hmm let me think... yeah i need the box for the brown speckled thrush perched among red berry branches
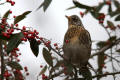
[63,15,92,80]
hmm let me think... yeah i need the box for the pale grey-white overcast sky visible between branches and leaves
[0,0,119,80]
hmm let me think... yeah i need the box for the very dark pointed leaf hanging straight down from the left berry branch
[29,39,39,57]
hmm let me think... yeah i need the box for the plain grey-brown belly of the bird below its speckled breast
[64,42,89,65]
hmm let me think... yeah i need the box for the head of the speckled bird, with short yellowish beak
[66,15,83,27]
